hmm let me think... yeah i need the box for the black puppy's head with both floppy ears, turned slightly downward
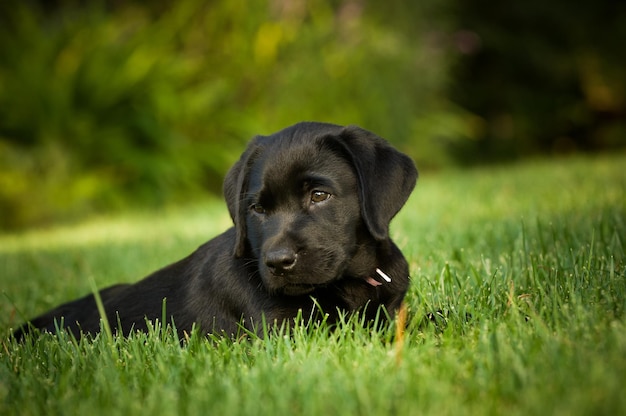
[224,123,417,295]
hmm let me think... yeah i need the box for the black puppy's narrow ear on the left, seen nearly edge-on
[223,136,264,257]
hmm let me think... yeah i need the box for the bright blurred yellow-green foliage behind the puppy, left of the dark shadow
[0,0,454,229]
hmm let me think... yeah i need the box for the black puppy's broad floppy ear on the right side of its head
[339,126,417,241]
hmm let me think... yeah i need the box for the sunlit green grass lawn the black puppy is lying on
[0,155,626,415]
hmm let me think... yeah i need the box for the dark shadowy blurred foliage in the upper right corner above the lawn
[448,0,626,163]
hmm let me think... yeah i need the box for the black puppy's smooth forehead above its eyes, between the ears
[250,140,356,191]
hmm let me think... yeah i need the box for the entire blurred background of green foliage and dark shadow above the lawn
[0,0,626,231]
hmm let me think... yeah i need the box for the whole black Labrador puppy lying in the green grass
[14,123,417,339]
